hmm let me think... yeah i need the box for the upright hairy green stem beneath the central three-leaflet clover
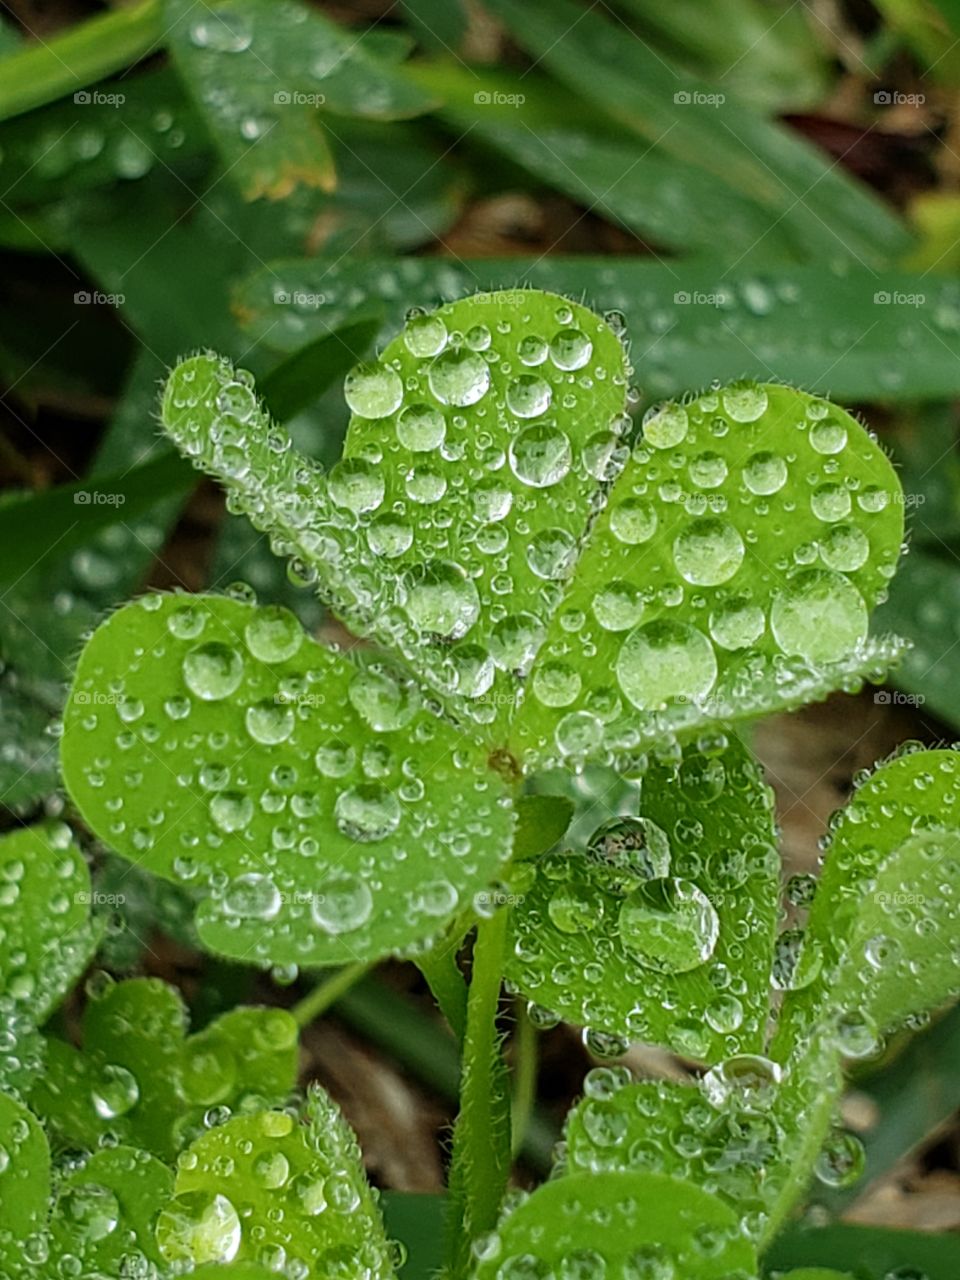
[449,908,512,1276]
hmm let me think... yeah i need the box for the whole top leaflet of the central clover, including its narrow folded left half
[164,291,627,732]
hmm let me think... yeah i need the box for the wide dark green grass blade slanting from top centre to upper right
[488,0,909,265]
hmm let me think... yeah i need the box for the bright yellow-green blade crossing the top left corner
[0,0,164,120]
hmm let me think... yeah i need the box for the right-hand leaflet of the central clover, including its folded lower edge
[511,381,904,767]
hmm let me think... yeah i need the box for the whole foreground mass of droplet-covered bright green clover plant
[0,290,960,1280]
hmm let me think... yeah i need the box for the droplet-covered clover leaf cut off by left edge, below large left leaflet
[0,822,99,1025]
